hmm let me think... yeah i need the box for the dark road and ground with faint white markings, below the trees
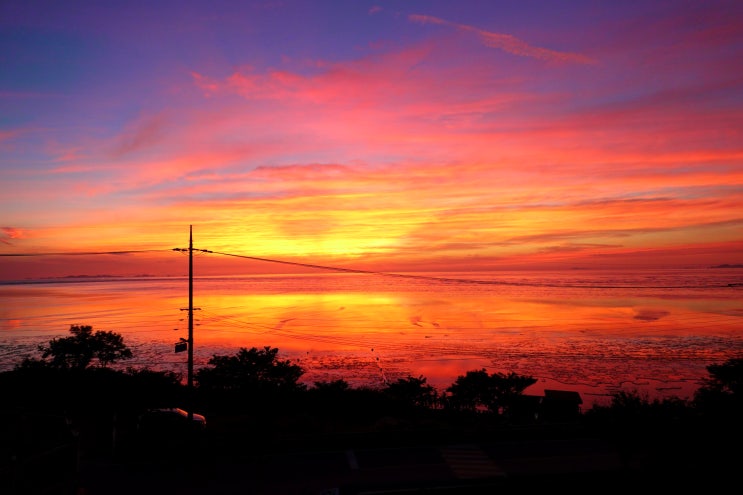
[8,414,742,495]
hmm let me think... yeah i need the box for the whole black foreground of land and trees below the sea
[5,348,743,495]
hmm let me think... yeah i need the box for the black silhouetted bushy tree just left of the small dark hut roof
[446,368,537,415]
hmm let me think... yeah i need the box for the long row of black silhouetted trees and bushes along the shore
[5,325,743,423]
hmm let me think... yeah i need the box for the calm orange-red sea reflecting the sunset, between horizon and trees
[0,268,743,407]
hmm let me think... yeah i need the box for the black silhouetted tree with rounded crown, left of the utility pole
[28,325,132,369]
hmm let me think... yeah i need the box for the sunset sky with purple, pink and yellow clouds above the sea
[0,0,743,280]
